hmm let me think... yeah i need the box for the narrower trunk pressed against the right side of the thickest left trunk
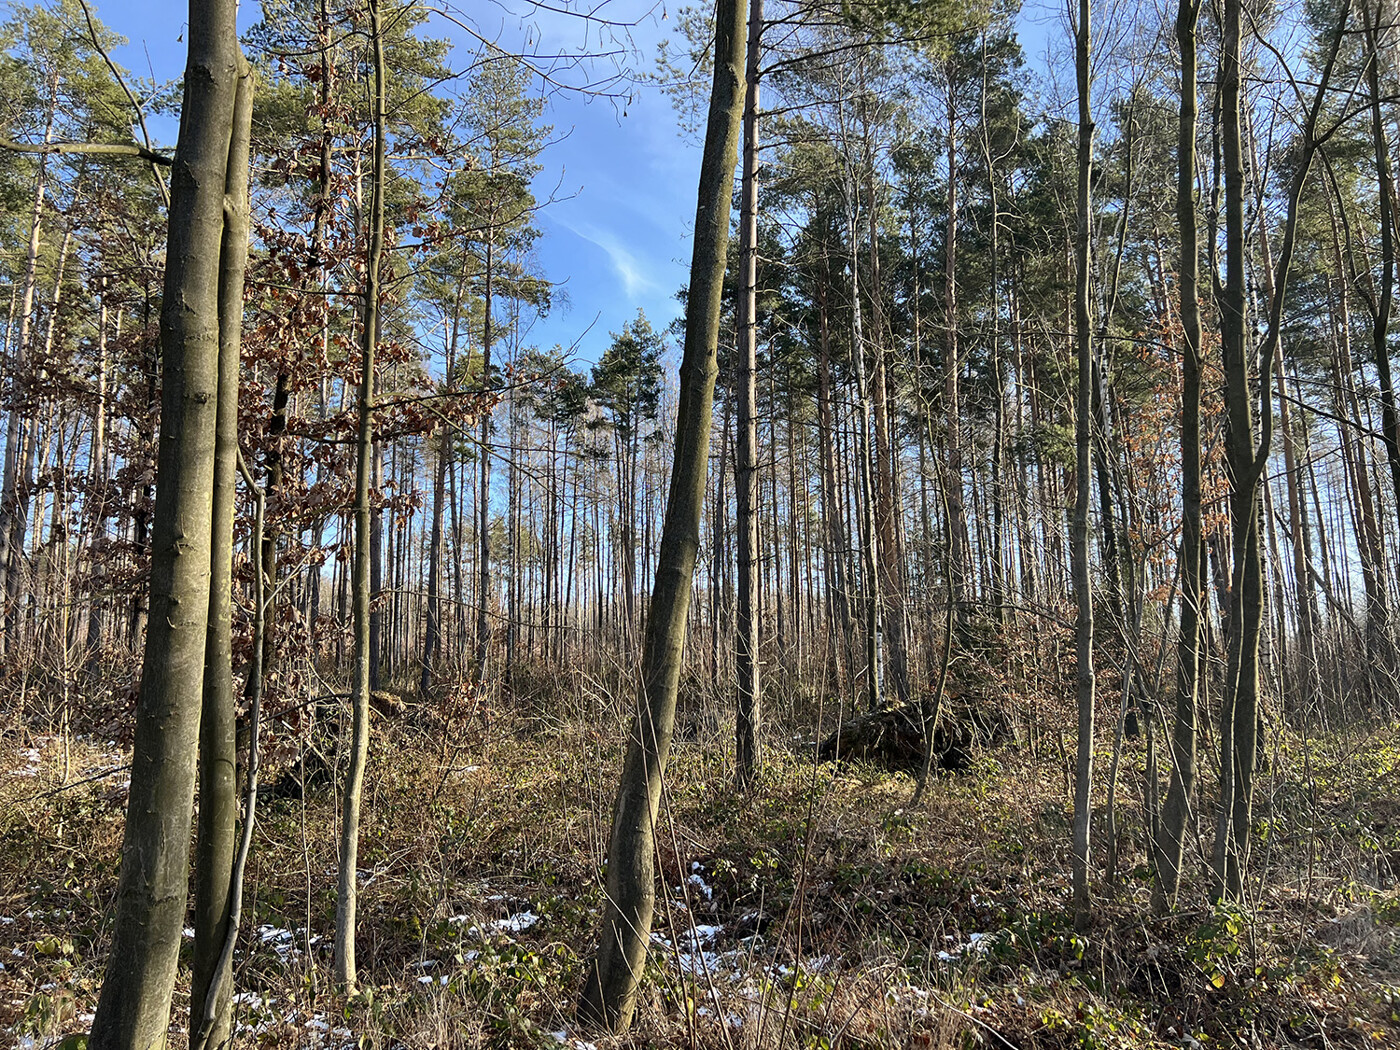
[189,63,254,1050]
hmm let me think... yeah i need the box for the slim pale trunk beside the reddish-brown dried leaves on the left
[335,0,385,991]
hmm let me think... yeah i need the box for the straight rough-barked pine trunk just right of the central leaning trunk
[734,0,763,791]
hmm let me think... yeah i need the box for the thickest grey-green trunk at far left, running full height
[90,0,242,1050]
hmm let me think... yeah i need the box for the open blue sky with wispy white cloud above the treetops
[99,0,1061,361]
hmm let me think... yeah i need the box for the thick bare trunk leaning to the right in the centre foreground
[578,0,745,1032]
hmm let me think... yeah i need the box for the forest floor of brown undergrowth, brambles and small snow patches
[0,666,1400,1050]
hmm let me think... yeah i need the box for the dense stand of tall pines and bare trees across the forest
[0,0,1400,1046]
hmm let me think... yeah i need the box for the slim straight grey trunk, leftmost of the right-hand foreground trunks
[1070,0,1093,930]
